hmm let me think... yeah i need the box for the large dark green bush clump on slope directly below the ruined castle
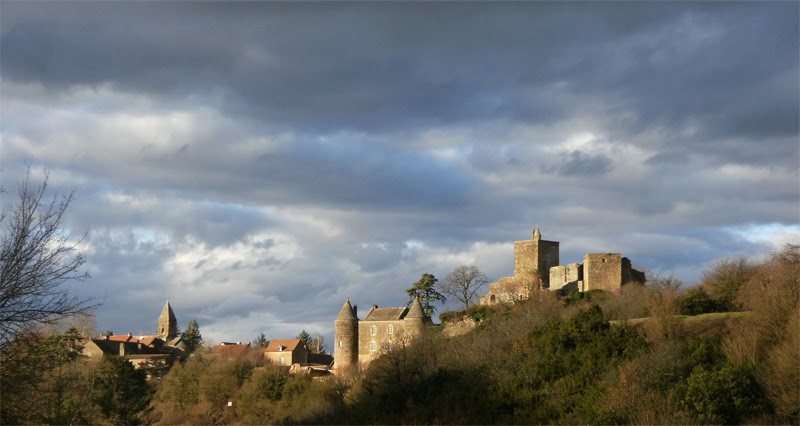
[506,306,646,423]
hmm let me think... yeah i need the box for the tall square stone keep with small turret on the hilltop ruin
[514,226,559,288]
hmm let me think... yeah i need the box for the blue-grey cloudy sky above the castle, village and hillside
[0,0,800,348]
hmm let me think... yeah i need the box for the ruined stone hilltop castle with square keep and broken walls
[480,227,645,305]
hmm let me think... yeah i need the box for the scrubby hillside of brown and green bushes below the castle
[2,246,800,424]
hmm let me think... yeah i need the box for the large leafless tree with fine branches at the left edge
[0,169,94,349]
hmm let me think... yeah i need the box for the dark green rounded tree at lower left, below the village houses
[91,357,153,425]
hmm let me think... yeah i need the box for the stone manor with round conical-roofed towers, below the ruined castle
[334,298,432,375]
